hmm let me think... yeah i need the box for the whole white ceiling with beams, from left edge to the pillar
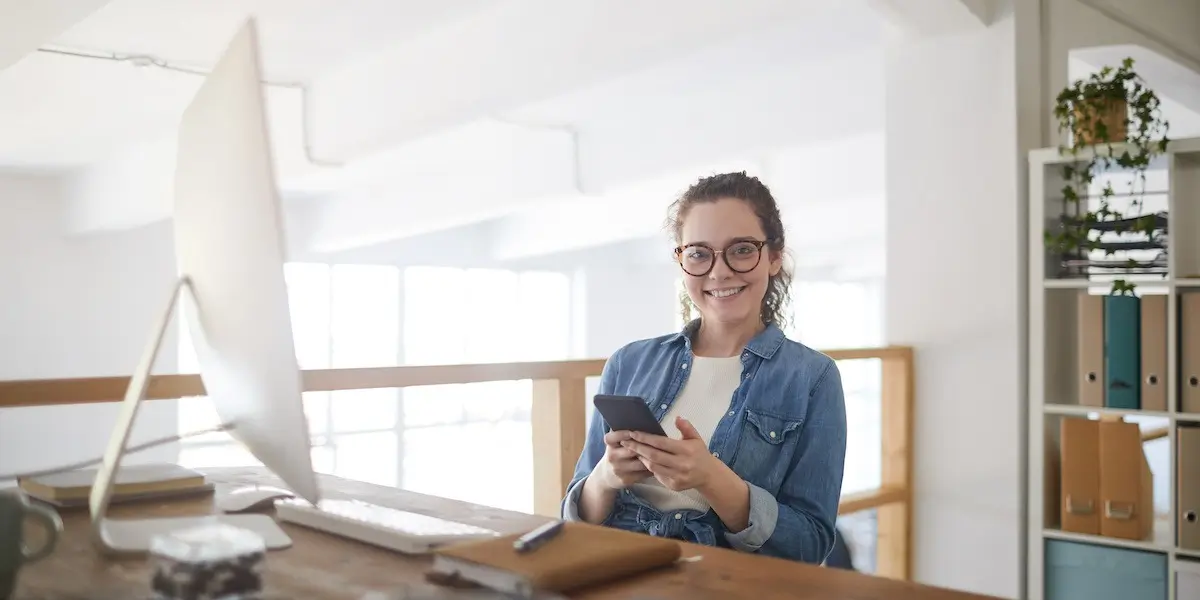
[0,0,884,272]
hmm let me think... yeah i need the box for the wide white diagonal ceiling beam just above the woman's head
[302,46,883,253]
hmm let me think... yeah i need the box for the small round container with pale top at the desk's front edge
[150,522,266,600]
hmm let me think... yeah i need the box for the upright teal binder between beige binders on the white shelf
[1104,295,1141,410]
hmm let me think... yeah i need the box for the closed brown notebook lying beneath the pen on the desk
[430,522,682,599]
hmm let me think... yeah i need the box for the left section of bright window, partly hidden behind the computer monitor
[179,263,401,485]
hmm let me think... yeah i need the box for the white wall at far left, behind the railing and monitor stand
[0,175,178,473]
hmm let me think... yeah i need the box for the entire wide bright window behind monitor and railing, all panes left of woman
[179,263,571,511]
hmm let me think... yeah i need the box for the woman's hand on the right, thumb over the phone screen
[622,416,725,492]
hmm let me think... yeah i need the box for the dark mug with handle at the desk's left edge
[0,488,62,599]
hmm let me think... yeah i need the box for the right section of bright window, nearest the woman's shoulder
[403,266,571,512]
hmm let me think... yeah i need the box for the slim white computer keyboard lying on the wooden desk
[275,498,500,554]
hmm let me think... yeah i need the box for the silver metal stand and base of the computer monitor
[88,277,292,556]
